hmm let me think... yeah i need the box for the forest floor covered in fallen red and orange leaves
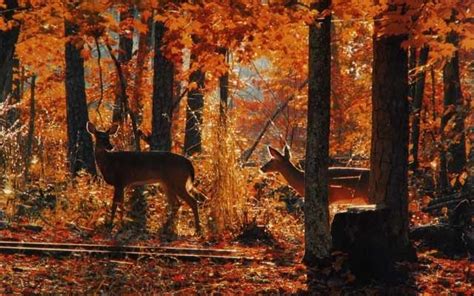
[0,213,474,295]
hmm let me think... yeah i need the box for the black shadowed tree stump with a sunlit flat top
[331,205,416,281]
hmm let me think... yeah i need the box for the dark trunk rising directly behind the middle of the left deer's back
[150,22,175,151]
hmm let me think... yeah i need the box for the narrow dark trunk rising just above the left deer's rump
[184,55,205,155]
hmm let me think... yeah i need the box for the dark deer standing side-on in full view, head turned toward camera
[86,122,207,234]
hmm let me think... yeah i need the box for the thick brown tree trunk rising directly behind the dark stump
[369,19,411,258]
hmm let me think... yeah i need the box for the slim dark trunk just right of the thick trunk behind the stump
[411,46,429,172]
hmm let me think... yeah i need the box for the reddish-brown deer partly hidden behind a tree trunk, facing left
[260,146,370,204]
